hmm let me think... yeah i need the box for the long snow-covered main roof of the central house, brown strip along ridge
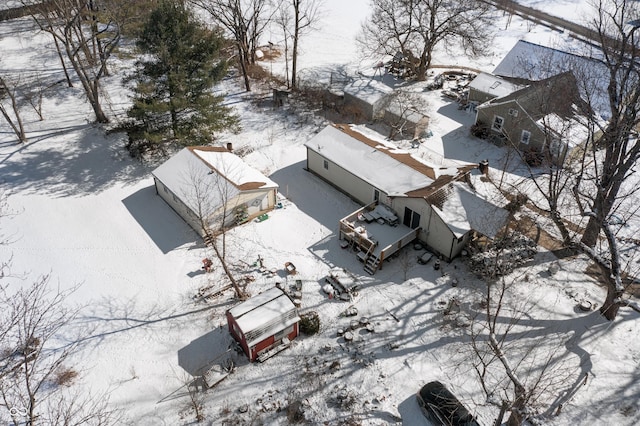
[305,125,470,196]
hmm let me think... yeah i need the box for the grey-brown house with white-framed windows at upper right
[476,72,591,164]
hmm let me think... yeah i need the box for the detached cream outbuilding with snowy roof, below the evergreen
[152,146,278,237]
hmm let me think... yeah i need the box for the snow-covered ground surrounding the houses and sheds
[0,0,640,425]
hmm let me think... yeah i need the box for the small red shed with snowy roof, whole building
[227,287,300,361]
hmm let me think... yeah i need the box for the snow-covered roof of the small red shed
[229,287,300,347]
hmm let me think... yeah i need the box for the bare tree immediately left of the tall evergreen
[23,0,121,123]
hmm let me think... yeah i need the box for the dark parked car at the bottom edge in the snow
[416,381,480,426]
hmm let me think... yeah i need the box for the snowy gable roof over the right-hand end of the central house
[433,182,509,238]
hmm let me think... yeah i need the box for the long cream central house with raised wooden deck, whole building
[305,125,508,273]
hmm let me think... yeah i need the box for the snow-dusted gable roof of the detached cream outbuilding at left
[152,146,278,215]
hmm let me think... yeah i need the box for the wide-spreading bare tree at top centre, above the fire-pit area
[358,0,492,80]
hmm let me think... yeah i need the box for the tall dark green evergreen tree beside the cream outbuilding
[128,0,238,157]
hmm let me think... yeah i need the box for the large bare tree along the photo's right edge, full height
[524,0,640,320]
